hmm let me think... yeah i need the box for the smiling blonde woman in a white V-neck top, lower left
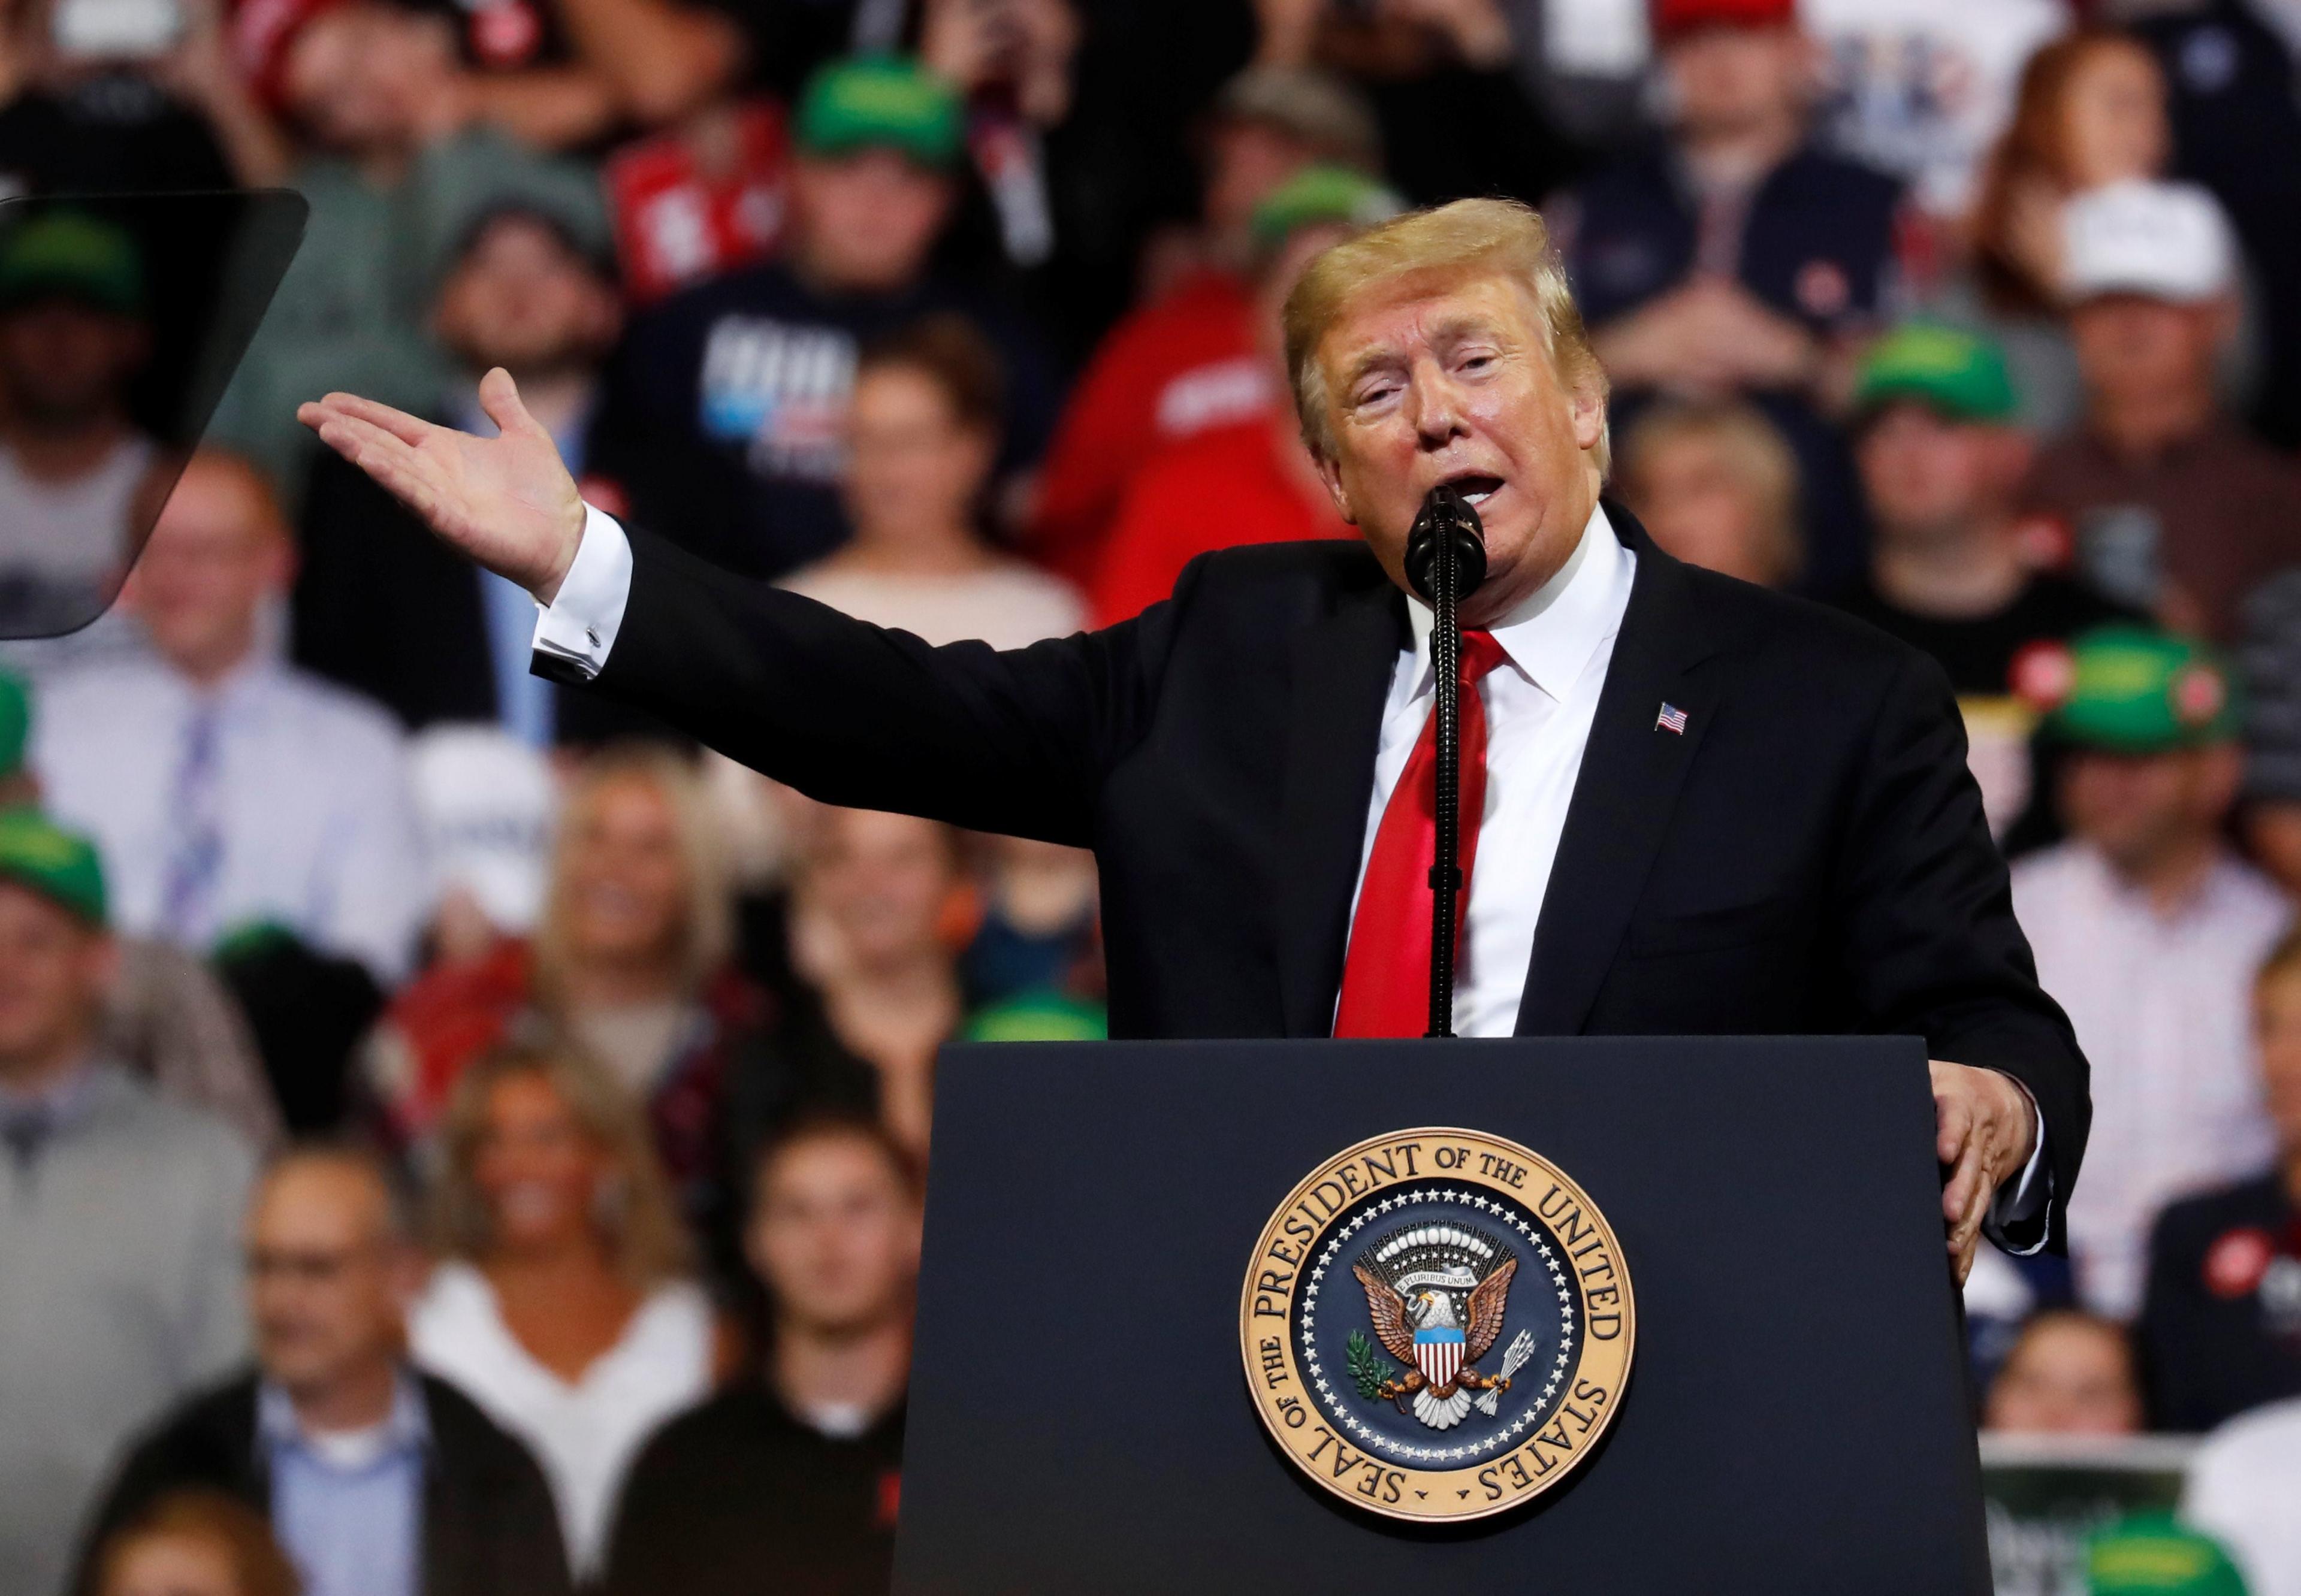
[410,1048,715,1577]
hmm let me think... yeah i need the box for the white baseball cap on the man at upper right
[2062,179,2236,304]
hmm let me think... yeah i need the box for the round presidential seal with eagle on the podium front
[1238,1129,1636,1520]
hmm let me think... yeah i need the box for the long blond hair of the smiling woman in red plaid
[534,743,734,1007]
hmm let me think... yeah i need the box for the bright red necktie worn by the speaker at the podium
[1334,633,1503,1037]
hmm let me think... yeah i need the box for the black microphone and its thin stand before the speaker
[1406,485,1487,1037]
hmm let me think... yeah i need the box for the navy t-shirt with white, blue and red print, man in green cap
[598,262,1061,577]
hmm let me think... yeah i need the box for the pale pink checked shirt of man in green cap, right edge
[2013,842,2292,1318]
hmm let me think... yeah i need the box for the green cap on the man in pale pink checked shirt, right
[2048,621,2239,754]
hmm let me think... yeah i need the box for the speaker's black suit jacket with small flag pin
[539,506,2089,1241]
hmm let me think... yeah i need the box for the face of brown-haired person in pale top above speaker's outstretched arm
[844,365,992,548]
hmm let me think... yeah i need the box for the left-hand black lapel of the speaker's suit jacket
[1277,572,1406,1037]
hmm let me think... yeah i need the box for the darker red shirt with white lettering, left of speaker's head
[1031,271,1279,582]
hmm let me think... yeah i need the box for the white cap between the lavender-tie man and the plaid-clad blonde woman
[407,724,557,933]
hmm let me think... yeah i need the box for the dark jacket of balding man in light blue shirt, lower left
[74,1373,568,1596]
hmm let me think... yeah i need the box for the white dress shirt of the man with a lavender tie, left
[32,651,430,984]
